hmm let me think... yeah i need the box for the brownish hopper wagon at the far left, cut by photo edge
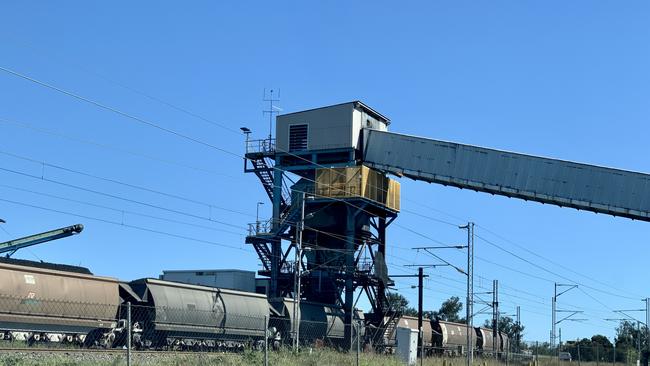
[0,260,121,347]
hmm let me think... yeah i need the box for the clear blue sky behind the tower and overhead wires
[0,1,650,341]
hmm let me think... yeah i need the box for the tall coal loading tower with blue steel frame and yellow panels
[243,101,400,346]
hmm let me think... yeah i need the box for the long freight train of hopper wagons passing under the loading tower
[0,258,508,356]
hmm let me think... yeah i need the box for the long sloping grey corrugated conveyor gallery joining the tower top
[364,129,650,221]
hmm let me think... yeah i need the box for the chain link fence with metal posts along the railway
[6,295,640,366]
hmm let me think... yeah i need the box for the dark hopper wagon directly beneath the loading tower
[270,298,365,346]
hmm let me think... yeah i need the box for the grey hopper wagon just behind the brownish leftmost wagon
[123,278,270,350]
